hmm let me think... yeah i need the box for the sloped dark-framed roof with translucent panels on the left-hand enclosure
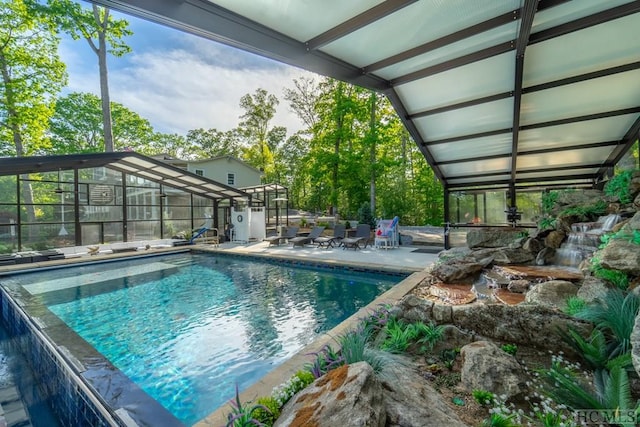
[0,152,251,199]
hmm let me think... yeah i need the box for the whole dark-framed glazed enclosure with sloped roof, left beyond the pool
[0,152,269,253]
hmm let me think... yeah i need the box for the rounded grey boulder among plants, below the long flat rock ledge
[460,341,527,399]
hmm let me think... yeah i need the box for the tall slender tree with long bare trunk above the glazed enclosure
[30,0,133,151]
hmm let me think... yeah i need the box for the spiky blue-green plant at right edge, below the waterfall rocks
[576,289,640,357]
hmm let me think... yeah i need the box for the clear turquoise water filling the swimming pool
[32,254,402,425]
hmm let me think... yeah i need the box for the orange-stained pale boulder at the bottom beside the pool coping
[274,362,387,427]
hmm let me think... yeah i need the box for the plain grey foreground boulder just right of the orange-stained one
[380,360,466,427]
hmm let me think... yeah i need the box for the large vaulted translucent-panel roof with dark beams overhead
[90,0,640,190]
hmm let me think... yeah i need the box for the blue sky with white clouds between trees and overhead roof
[60,7,317,135]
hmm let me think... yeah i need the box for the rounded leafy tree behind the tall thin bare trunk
[49,92,154,154]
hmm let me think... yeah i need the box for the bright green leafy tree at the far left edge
[0,0,67,227]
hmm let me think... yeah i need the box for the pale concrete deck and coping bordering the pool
[0,242,438,427]
